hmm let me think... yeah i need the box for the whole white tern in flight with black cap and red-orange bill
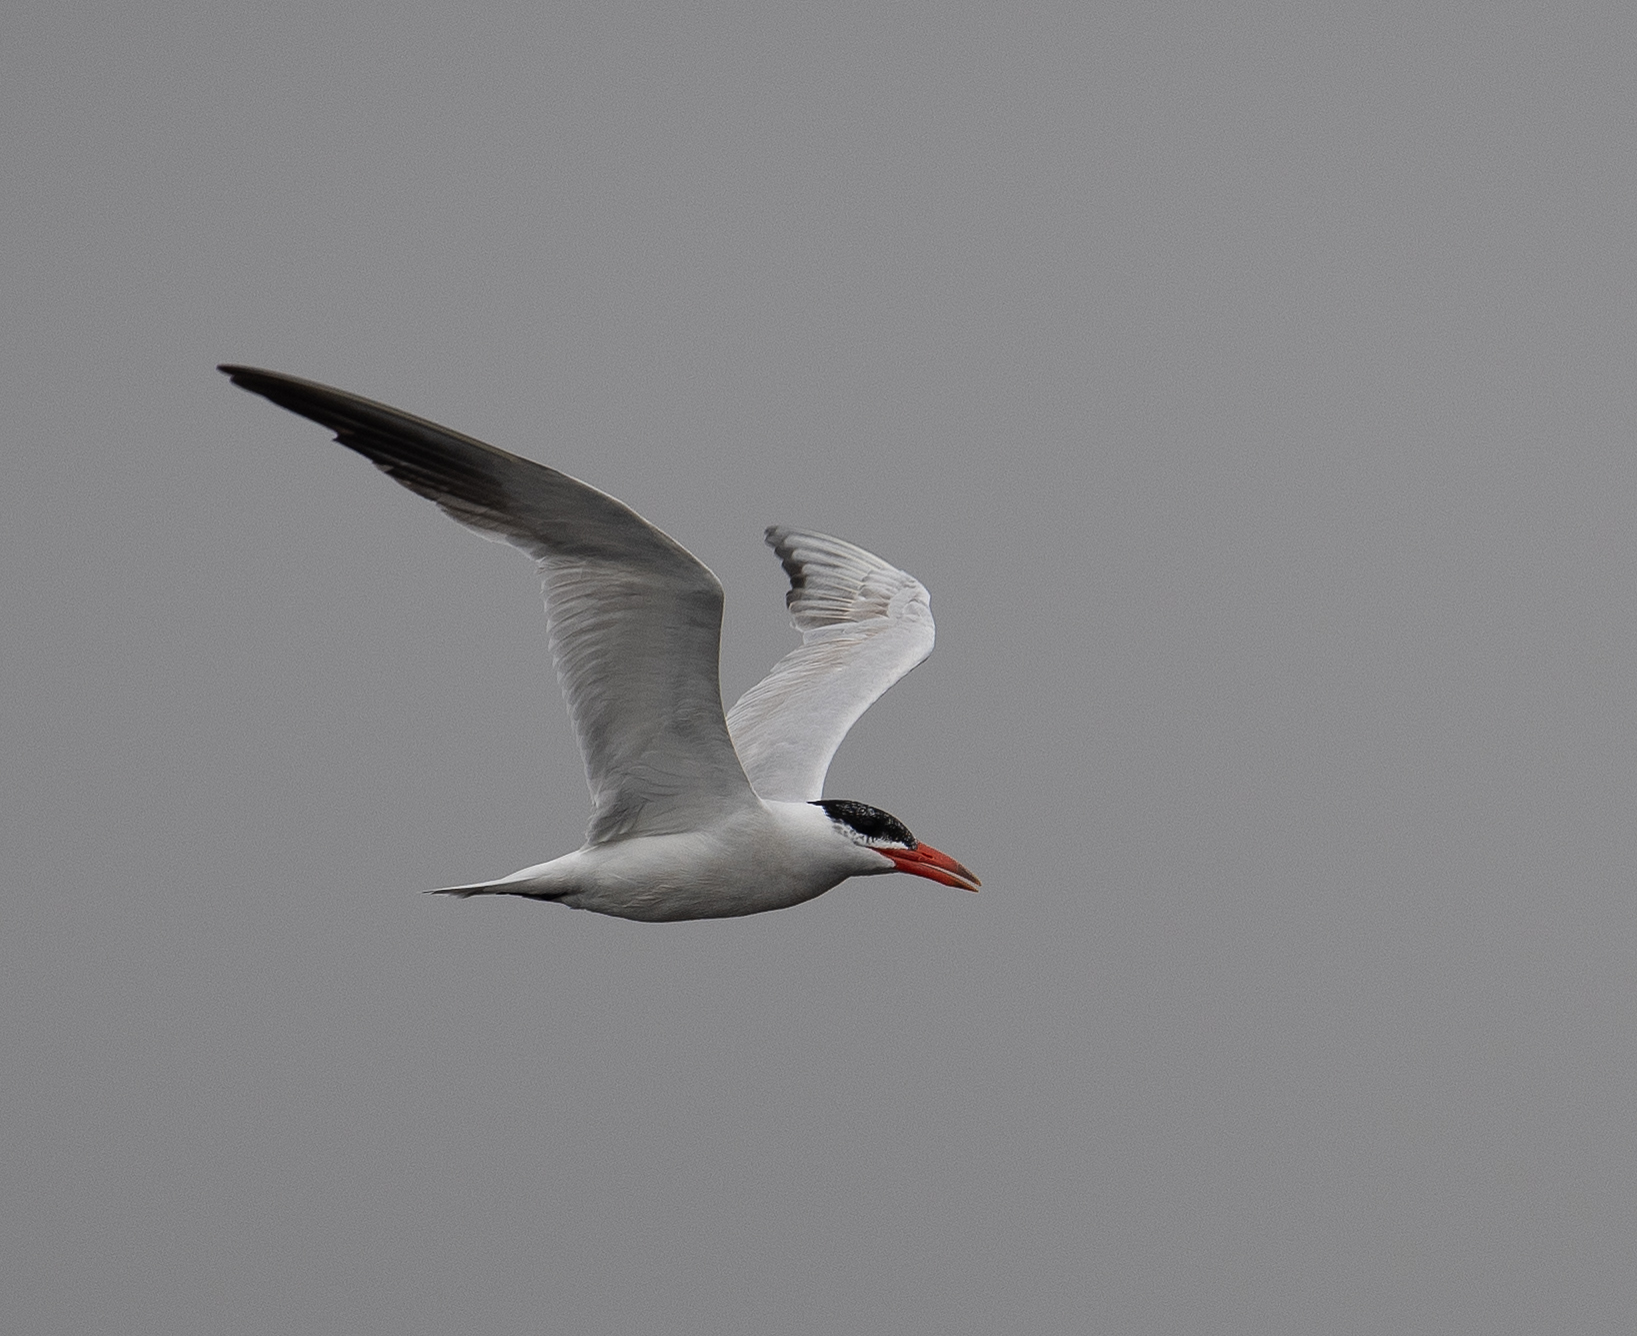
[218,363,979,923]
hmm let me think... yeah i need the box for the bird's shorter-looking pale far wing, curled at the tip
[727,526,933,802]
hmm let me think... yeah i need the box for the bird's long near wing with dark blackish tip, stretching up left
[221,367,755,843]
